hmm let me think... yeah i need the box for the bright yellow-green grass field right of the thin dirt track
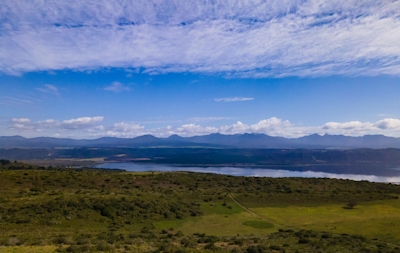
[251,199,400,244]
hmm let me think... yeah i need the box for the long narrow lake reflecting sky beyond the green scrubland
[95,163,400,184]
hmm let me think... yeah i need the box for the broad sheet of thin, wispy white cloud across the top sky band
[0,0,400,77]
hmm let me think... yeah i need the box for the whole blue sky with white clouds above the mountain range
[0,0,400,139]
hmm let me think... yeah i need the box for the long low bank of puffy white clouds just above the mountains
[9,116,400,138]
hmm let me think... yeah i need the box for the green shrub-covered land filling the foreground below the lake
[0,160,400,253]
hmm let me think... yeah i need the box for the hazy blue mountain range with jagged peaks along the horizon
[0,134,400,149]
